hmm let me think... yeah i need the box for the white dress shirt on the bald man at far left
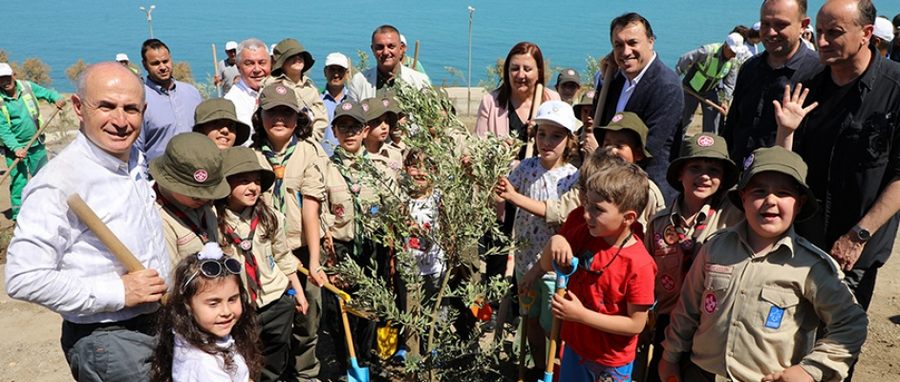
[6,132,169,324]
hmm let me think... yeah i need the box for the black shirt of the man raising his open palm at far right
[794,50,900,269]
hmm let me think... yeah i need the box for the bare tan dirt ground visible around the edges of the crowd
[0,97,900,382]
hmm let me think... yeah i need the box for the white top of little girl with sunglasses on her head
[172,334,250,382]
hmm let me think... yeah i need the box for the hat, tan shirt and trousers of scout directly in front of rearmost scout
[257,83,325,379]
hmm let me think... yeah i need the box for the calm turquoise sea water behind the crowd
[0,0,836,91]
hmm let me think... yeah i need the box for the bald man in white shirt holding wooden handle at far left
[6,62,170,382]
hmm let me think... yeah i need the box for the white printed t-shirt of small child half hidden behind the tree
[406,191,444,276]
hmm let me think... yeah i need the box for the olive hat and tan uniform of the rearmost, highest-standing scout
[262,38,328,143]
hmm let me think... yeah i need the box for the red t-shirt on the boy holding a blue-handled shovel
[559,211,656,367]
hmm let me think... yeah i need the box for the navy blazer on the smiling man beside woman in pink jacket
[595,55,684,205]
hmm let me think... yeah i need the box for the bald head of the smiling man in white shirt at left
[72,62,146,162]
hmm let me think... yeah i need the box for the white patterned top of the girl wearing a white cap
[509,157,578,277]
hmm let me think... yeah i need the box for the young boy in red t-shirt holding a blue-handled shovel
[526,164,656,382]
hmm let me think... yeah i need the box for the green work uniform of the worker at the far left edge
[0,81,62,220]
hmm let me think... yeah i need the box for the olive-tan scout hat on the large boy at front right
[728,146,818,221]
